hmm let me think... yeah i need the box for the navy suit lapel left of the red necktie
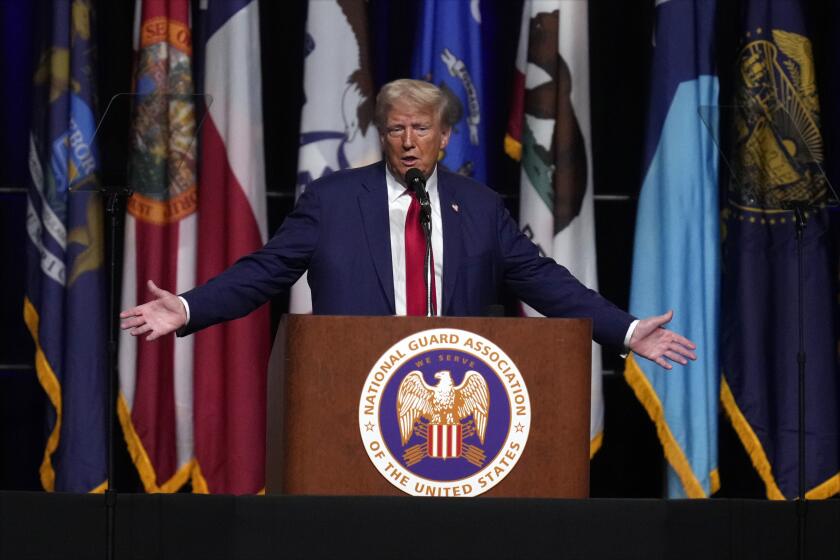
[358,165,396,315]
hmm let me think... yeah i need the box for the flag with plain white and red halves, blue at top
[193,0,270,494]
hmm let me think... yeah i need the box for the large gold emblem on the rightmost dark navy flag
[730,29,830,210]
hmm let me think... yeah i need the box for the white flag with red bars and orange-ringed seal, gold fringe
[119,0,197,492]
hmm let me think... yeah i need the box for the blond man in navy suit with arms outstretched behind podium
[120,80,695,369]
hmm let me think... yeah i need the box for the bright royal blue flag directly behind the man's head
[411,0,488,183]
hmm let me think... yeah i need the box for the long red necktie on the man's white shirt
[405,191,437,316]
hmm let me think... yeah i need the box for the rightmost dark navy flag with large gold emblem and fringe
[721,0,840,499]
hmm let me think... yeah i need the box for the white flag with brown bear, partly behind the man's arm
[505,0,604,455]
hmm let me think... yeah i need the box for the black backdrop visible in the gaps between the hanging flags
[0,0,840,497]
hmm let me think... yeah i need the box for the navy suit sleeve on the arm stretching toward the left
[178,184,321,336]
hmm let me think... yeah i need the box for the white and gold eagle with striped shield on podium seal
[397,370,490,466]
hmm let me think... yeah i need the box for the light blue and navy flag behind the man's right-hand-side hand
[625,0,720,498]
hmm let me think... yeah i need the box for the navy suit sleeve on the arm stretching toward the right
[496,199,635,346]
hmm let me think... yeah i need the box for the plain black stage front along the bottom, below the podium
[0,492,840,560]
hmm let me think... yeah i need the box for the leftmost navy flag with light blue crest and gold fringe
[24,0,108,492]
